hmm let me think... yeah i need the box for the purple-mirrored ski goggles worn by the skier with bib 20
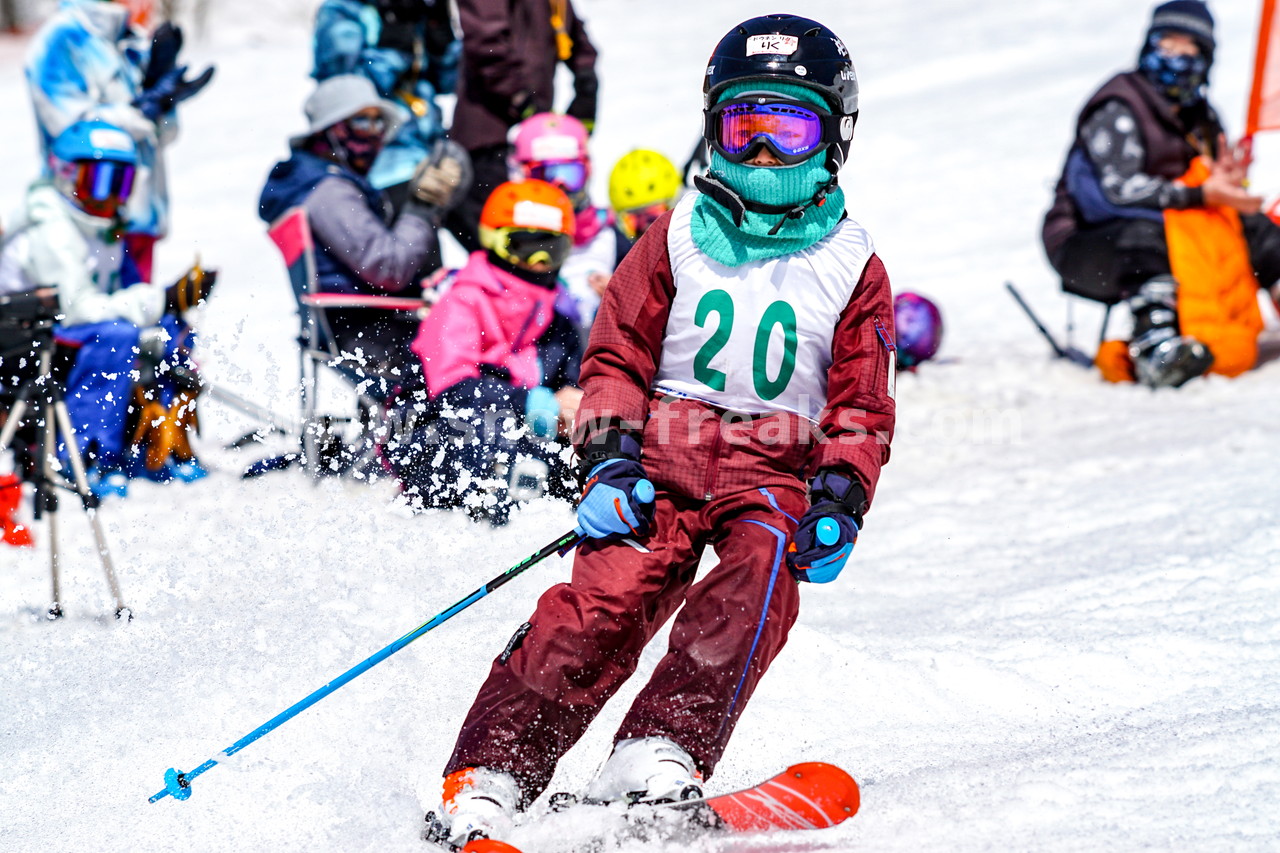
[704,97,852,165]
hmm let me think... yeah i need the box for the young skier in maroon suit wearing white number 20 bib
[426,15,895,844]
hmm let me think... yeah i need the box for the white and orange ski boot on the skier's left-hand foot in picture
[422,767,520,848]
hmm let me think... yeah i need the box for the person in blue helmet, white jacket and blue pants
[0,116,216,496]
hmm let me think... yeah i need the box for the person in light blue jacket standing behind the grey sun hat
[311,0,462,211]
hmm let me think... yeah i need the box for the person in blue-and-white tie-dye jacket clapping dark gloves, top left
[26,0,214,279]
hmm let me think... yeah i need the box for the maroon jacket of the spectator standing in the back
[449,0,598,151]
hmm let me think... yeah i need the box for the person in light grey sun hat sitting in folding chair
[259,74,470,391]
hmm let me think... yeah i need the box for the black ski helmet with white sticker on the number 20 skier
[703,14,858,172]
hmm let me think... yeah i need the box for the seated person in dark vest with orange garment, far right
[1043,0,1280,387]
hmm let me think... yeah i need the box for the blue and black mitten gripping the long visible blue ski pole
[577,429,654,539]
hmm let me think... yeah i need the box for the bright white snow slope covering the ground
[0,0,1280,852]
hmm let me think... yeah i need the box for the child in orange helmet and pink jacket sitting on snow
[387,181,582,525]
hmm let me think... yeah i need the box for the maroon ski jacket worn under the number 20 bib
[575,213,895,501]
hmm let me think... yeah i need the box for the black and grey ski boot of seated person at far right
[1129,275,1213,388]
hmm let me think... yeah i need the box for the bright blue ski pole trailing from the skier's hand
[147,530,582,803]
